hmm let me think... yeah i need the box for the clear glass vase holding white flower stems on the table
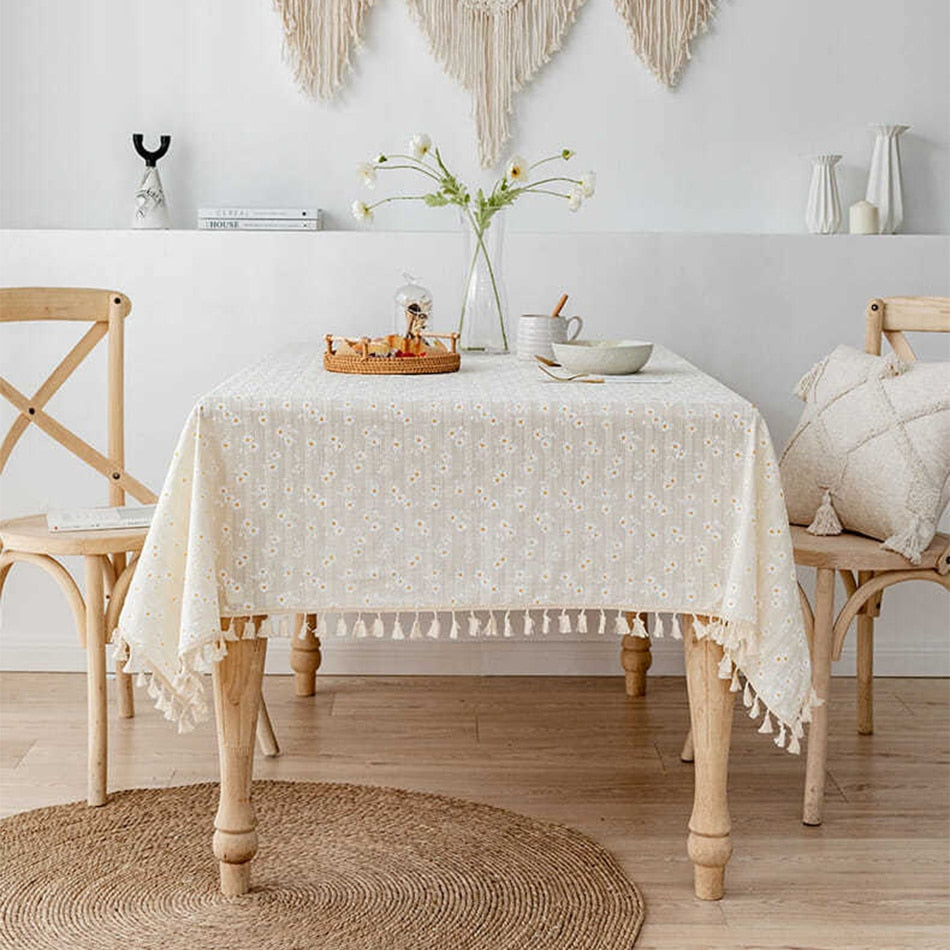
[458,214,508,353]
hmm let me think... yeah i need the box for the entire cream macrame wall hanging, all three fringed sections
[275,0,716,167]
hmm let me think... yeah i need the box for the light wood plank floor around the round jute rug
[0,673,950,950]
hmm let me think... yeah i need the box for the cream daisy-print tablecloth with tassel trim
[116,347,812,751]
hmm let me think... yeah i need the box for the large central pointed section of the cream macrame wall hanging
[408,0,584,168]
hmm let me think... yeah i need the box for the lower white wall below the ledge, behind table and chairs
[0,230,950,675]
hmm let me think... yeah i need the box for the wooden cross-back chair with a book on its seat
[0,287,277,805]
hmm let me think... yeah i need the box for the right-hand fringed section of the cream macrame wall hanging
[616,0,716,86]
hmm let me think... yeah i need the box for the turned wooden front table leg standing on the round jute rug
[212,620,267,897]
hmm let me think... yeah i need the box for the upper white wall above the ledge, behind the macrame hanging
[0,0,950,234]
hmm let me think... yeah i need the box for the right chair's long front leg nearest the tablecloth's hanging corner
[802,568,835,825]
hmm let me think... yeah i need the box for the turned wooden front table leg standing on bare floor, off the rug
[683,618,735,900]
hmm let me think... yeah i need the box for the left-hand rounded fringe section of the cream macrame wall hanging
[274,0,373,99]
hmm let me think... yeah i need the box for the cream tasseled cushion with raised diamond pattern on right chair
[781,346,950,563]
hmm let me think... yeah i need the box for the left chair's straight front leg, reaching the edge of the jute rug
[85,555,109,805]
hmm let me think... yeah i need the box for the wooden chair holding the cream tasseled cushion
[792,297,950,825]
